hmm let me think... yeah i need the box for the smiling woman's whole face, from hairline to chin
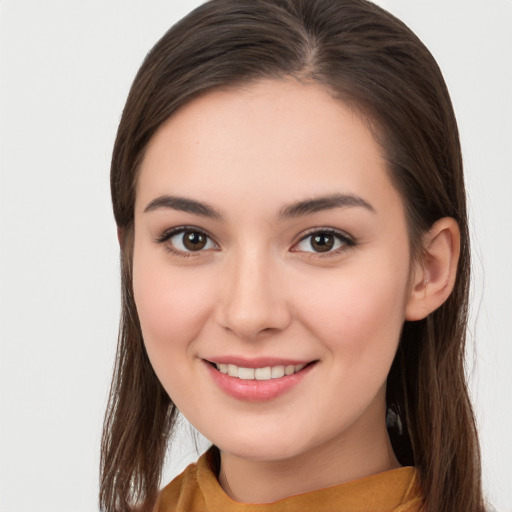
[133,80,411,460]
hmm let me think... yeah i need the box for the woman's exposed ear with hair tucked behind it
[405,217,460,321]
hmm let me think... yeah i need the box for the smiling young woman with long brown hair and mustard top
[100,0,483,512]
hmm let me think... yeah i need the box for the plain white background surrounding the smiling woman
[0,0,512,512]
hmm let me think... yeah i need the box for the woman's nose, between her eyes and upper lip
[217,250,291,340]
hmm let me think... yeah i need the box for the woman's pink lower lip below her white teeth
[204,361,316,402]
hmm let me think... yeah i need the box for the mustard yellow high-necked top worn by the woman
[156,449,421,512]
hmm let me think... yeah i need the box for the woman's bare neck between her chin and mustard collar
[219,398,400,503]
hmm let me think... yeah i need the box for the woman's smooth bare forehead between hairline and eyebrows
[136,80,399,216]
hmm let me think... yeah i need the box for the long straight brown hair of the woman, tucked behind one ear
[100,0,483,512]
